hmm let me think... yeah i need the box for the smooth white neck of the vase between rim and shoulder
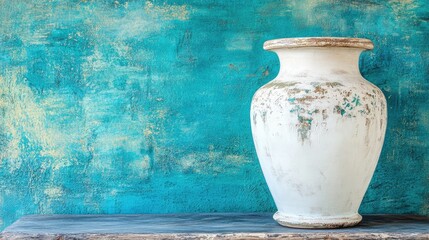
[273,47,364,80]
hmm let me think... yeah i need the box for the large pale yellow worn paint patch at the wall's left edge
[0,68,70,171]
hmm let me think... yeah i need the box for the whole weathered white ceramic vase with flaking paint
[250,38,387,228]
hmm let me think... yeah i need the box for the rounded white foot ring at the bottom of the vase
[273,212,362,228]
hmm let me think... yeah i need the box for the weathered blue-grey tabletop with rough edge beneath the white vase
[0,213,429,240]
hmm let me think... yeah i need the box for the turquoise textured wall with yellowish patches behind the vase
[0,0,429,229]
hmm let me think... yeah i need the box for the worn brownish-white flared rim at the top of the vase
[264,37,374,50]
